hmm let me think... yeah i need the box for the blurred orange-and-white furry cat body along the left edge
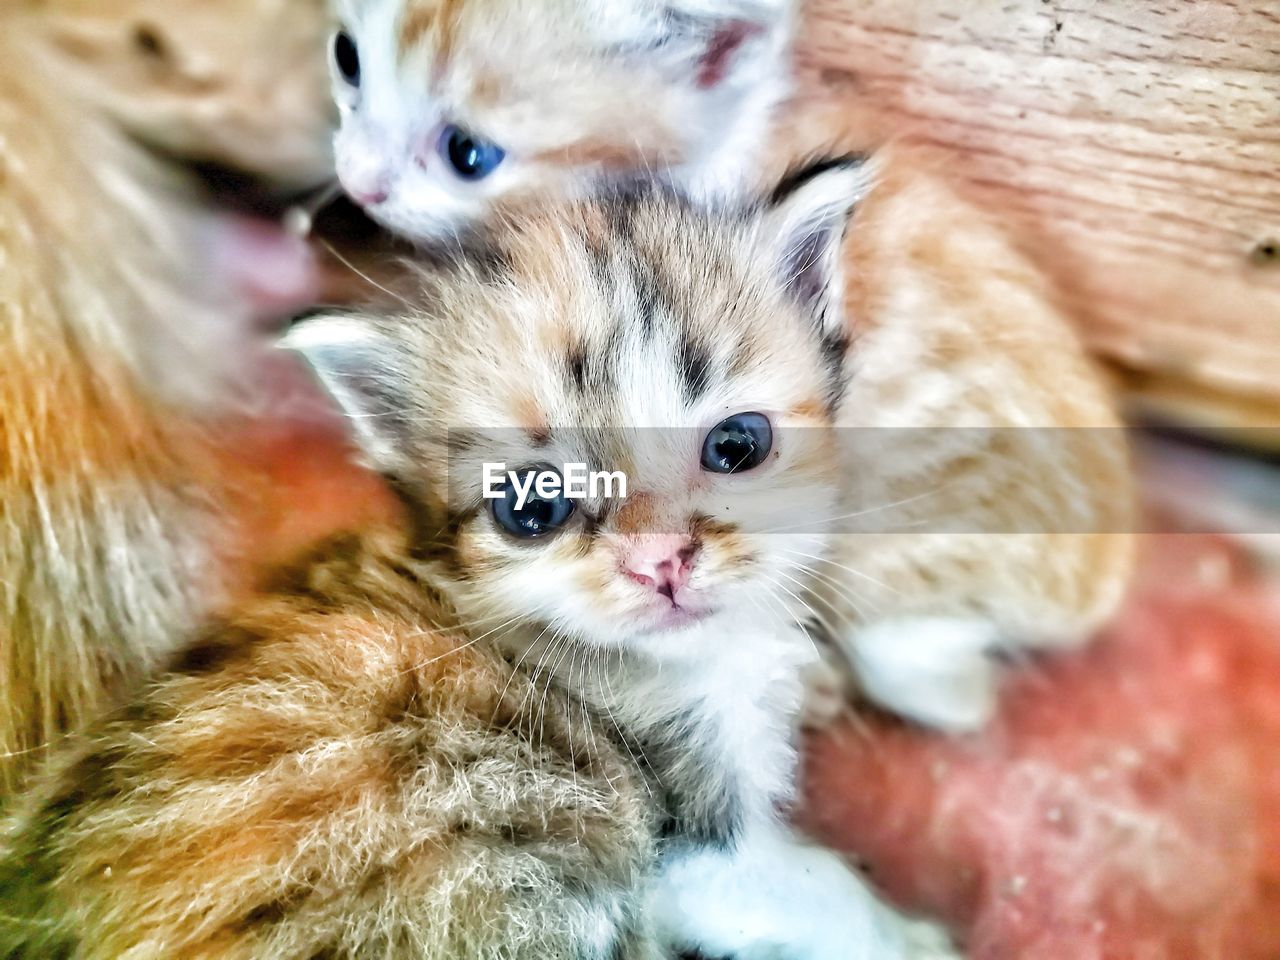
[0,3,335,797]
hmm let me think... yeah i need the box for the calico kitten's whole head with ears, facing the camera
[289,165,861,655]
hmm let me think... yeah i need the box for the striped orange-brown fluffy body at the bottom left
[0,534,659,960]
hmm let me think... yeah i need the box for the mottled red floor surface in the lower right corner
[806,535,1280,960]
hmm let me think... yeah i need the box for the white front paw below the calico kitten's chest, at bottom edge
[649,824,960,960]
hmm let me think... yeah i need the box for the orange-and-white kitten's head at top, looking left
[330,0,794,241]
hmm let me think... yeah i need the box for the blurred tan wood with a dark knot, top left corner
[30,0,333,189]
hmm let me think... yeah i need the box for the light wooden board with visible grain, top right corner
[799,0,1280,425]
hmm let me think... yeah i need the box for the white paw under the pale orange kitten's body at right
[841,617,1001,733]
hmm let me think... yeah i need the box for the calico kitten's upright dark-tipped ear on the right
[764,156,872,335]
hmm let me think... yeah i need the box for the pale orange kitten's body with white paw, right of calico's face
[805,150,1135,732]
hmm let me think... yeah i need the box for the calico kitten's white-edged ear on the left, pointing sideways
[280,314,412,474]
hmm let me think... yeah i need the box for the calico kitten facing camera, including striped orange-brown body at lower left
[0,163,948,960]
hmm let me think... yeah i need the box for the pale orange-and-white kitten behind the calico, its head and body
[325,0,1132,732]
